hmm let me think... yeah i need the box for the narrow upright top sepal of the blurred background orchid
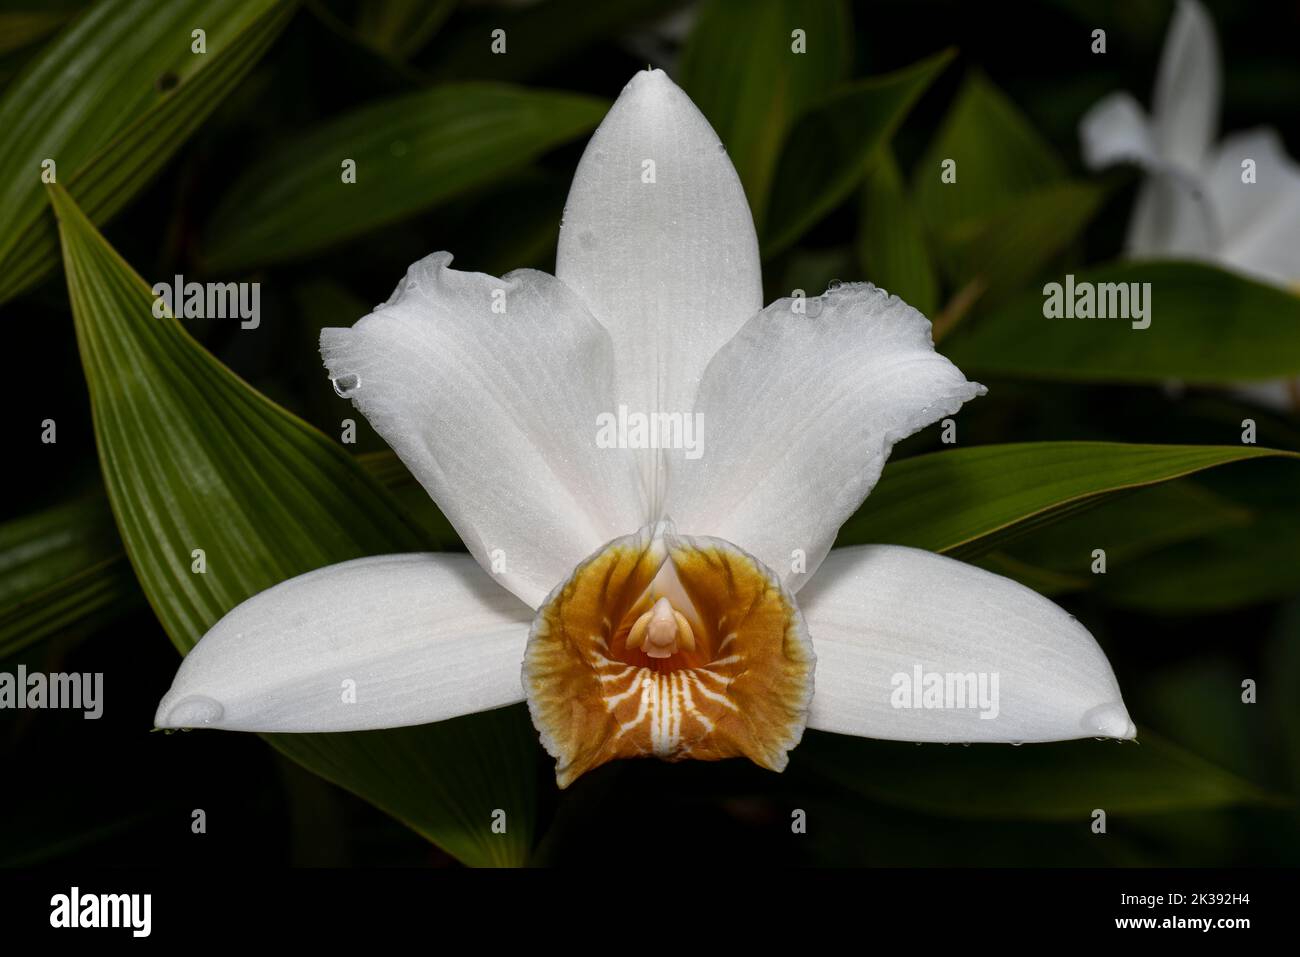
[1152,0,1221,170]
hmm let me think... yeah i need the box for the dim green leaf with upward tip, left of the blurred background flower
[913,72,1065,230]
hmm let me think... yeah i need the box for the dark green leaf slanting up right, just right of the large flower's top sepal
[762,51,953,256]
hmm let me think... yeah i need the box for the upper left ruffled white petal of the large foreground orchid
[321,252,646,607]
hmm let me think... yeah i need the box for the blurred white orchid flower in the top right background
[1079,0,1300,407]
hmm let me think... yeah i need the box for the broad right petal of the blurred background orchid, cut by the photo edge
[1205,129,1300,286]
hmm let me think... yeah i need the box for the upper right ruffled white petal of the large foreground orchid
[666,283,984,590]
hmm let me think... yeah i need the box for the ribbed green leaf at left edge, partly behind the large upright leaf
[0,495,140,658]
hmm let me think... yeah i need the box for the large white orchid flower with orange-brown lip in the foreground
[156,70,1135,787]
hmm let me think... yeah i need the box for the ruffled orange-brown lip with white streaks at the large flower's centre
[524,523,813,787]
